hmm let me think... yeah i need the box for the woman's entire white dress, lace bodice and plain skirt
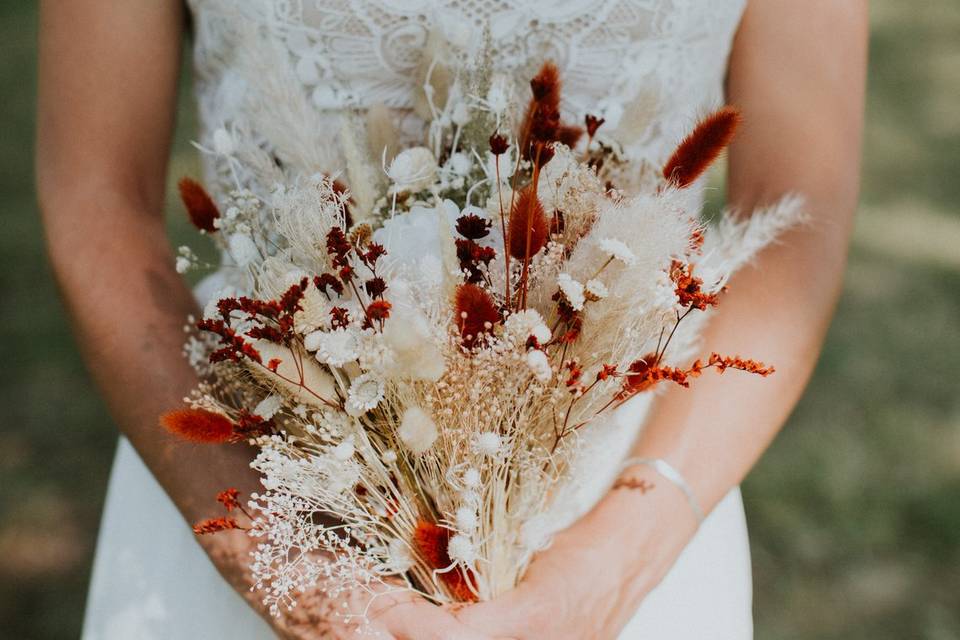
[82,0,753,640]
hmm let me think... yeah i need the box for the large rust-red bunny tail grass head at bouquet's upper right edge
[663,107,742,189]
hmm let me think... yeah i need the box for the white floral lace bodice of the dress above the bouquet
[190,0,746,192]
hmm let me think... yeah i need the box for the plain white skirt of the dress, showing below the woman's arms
[81,439,753,640]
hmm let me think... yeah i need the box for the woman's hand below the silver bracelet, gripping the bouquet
[456,468,696,640]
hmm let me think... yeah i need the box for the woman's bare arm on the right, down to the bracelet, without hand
[636,0,867,511]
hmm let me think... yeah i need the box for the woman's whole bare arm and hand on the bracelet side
[458,0,868,640]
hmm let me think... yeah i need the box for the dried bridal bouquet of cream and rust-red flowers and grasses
[161,64,799,612]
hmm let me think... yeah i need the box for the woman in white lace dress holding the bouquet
[38,0,866,640]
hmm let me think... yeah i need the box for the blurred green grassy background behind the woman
[0,0,960,640]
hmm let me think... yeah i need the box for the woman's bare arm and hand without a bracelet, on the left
[37,0,498,640]
